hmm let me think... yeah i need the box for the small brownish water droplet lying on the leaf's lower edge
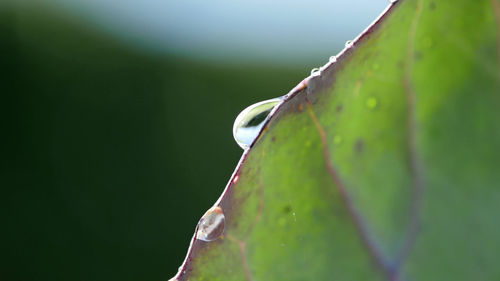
[196,207,226,242]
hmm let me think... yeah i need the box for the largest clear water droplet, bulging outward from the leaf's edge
[233,98,281,149]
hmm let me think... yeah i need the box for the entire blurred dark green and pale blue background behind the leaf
[0,0,387,281]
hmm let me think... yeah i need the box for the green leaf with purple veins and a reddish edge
[173,0,500,281]
